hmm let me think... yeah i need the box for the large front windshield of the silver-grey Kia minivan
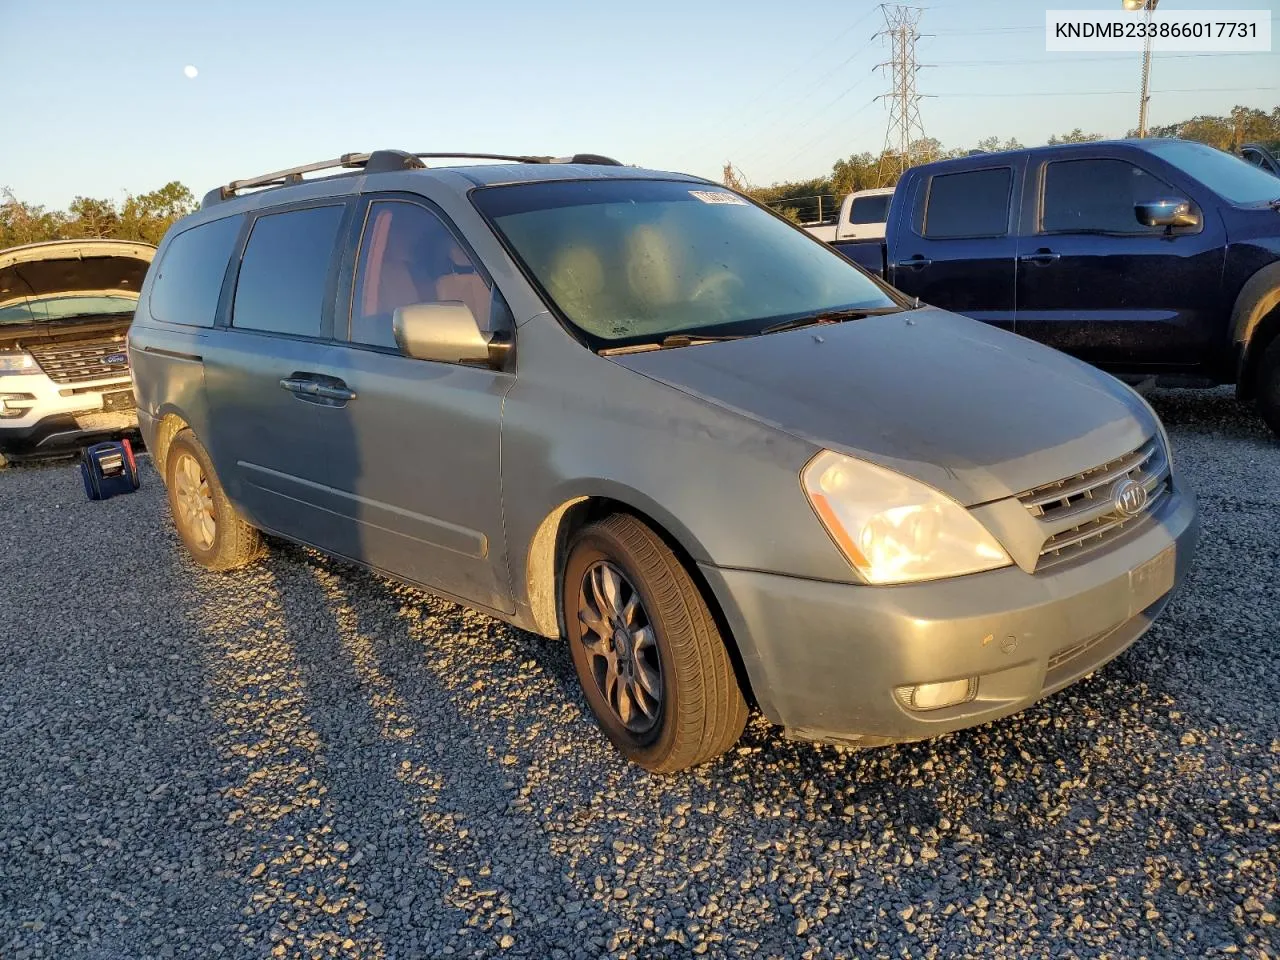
[472,179,899,348]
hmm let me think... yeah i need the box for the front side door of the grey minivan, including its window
[320,196,515,612]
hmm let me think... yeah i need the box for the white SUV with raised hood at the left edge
[0,239,155,466]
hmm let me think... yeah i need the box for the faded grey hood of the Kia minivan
[609,307,1156,506]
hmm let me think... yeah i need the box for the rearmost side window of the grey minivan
[150,216,243,326]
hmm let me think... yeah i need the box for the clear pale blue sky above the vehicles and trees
[0,0,1280,207]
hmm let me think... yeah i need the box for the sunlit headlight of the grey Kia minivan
[800,451,1012,584]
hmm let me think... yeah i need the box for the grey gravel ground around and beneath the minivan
[0,392,1280,960]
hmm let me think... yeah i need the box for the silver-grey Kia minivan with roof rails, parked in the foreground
[129,151,1197,772]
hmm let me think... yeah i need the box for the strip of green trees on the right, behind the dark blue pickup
[747,106,1280,220]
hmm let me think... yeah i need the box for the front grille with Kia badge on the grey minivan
[1018,438,1170,570]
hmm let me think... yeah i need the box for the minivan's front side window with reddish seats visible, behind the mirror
[348,200,493,348]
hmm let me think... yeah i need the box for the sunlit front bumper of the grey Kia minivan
[700,484,1199,746]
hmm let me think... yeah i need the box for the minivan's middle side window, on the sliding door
[232,205,343,337]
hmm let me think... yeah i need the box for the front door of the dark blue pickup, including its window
[1015,157,1225,372]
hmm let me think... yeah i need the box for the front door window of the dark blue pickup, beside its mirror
[1041,157,1178,233]
